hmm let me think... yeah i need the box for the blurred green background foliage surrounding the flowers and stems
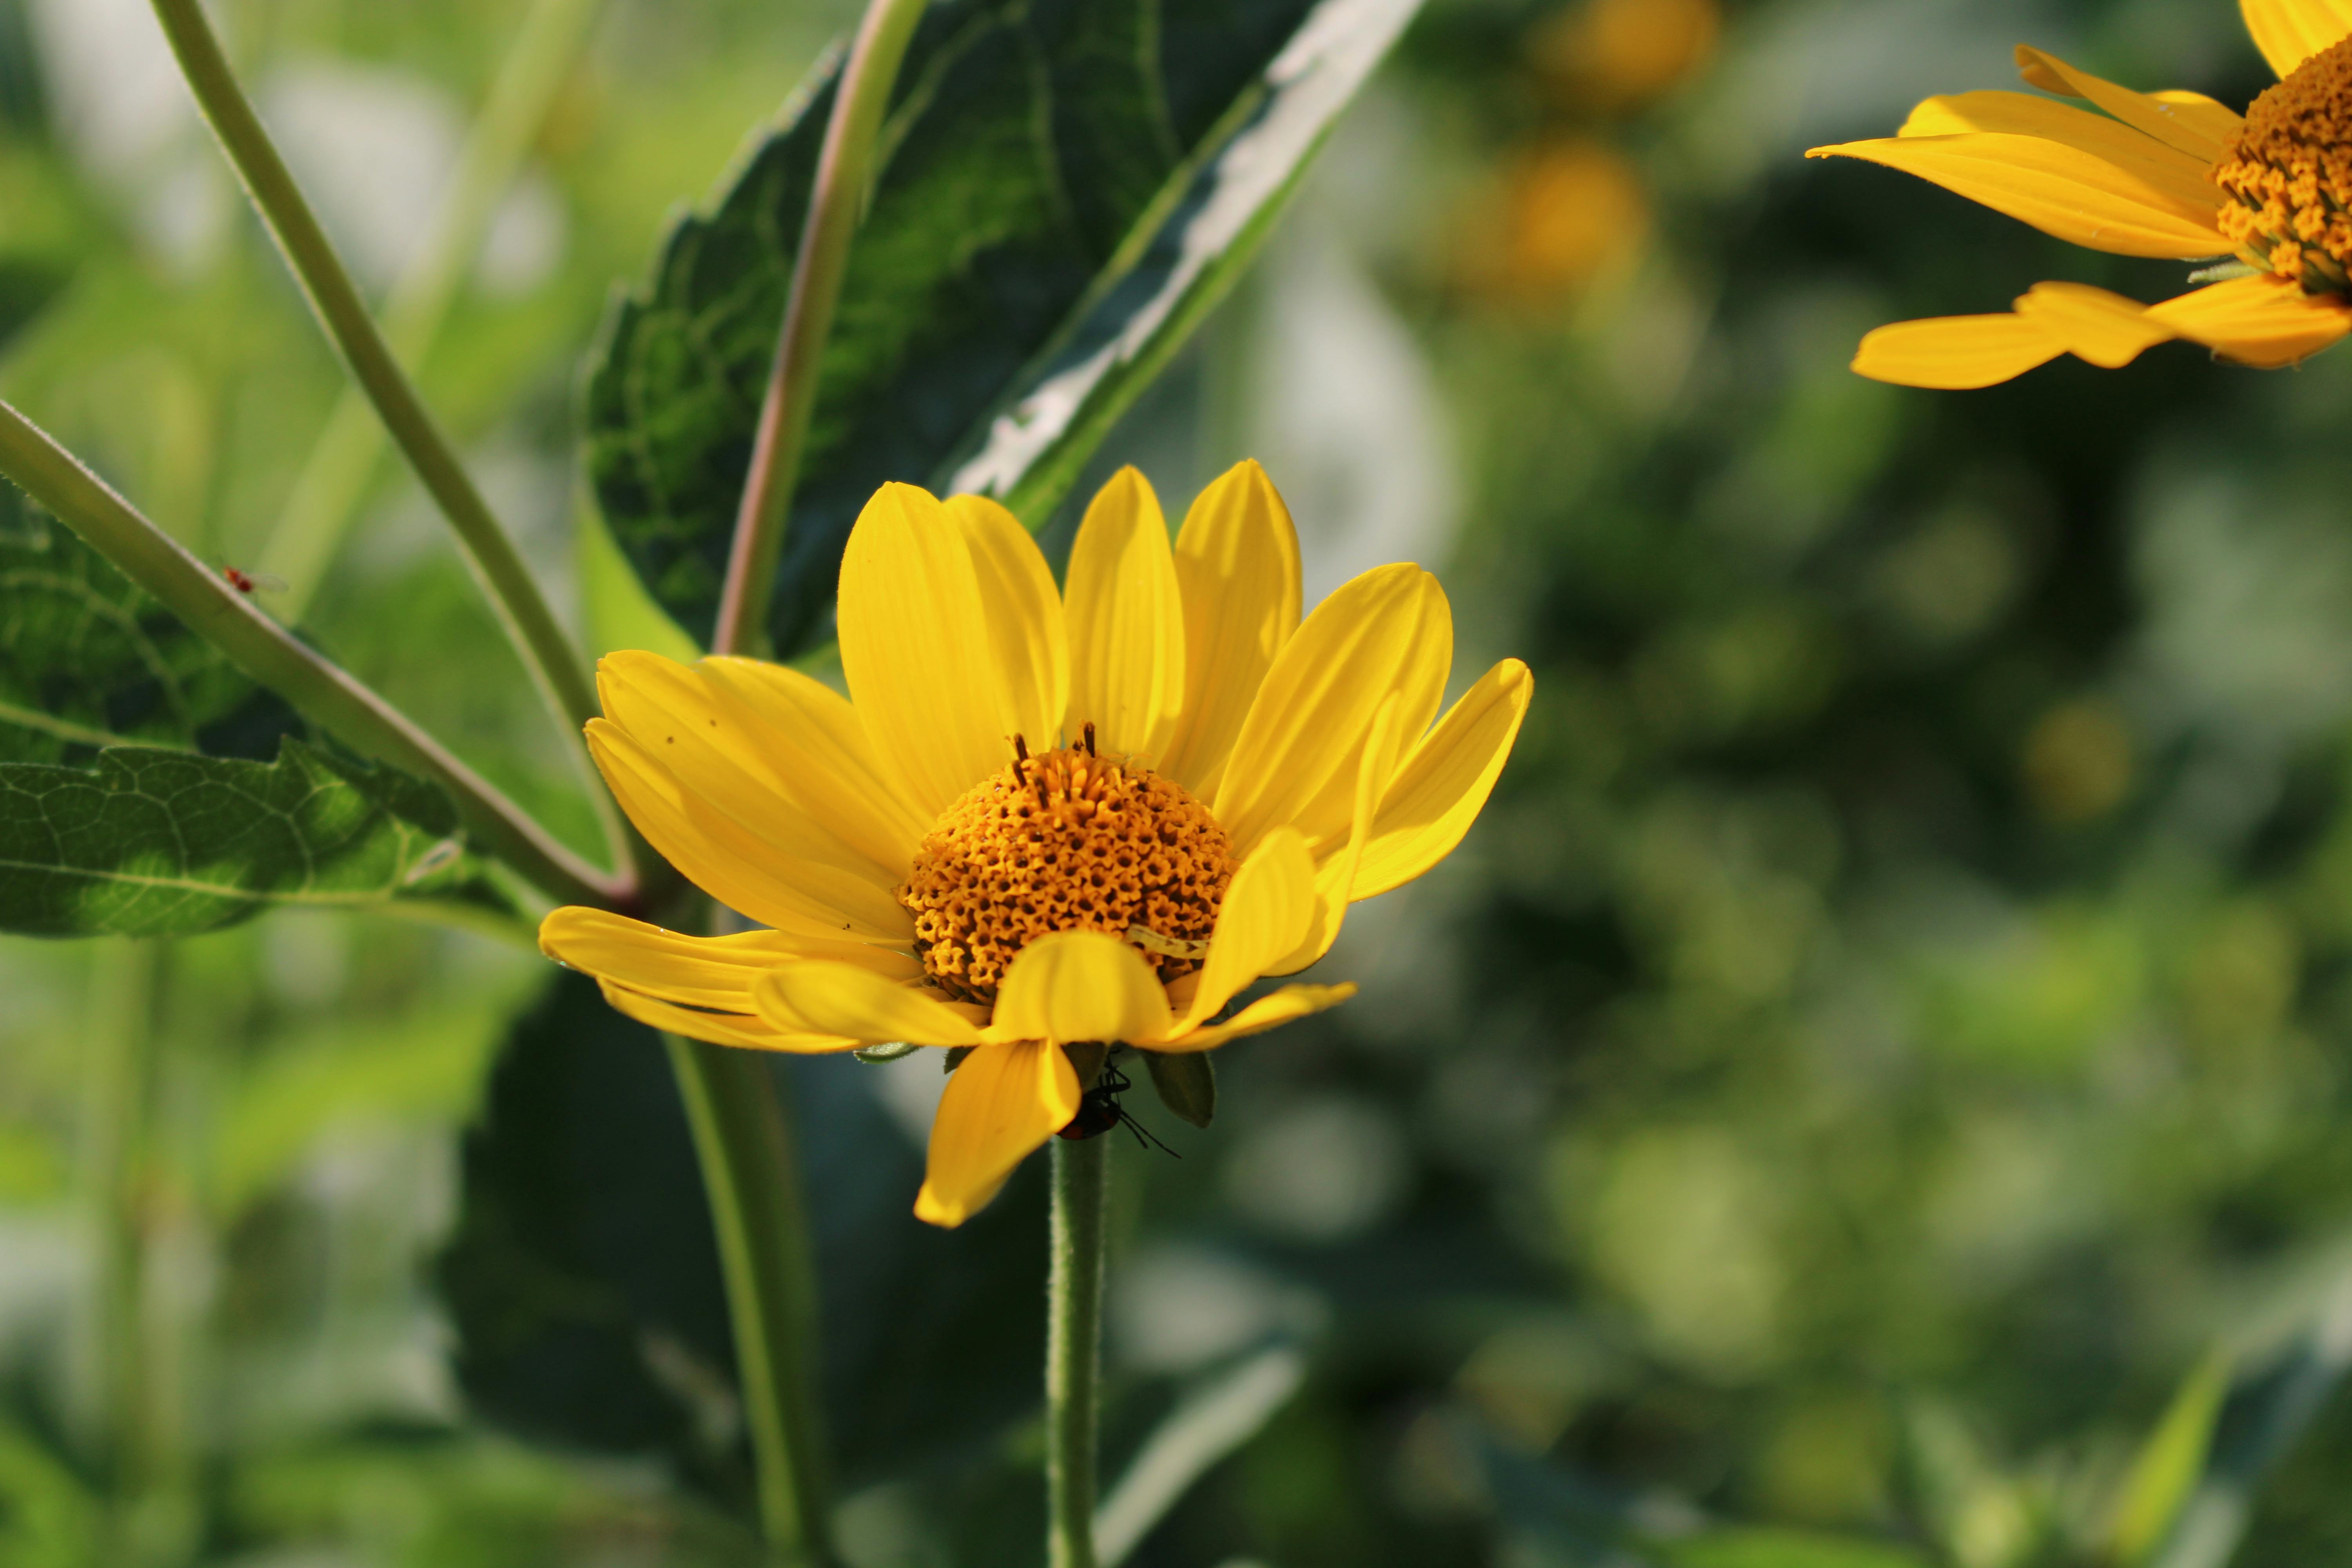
[0,0,2352,1568]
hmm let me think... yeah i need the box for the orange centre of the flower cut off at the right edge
[2213,38,2352,294]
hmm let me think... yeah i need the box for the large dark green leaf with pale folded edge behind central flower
[588,0,1418,656]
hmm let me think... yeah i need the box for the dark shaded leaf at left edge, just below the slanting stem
[0,484,303,762]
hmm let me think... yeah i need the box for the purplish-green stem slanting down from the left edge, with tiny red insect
[0,402,637,907]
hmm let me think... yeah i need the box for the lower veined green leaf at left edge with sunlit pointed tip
[0,738,510,936]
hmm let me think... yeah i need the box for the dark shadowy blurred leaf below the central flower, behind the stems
[440,973,1044,1504]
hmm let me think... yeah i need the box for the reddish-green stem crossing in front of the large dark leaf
[710,0,929,653]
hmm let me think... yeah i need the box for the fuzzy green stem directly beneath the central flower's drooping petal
[1044,1138,1110,1568]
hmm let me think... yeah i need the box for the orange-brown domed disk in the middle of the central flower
[898,748,1235,1004]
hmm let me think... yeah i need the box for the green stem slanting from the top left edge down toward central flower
[138,0,633,832]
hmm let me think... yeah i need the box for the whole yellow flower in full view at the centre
[539,463,1534,1225]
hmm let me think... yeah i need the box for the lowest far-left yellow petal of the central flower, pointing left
[539,905,922,1013]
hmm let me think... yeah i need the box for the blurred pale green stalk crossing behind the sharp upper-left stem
[256,0,602,611]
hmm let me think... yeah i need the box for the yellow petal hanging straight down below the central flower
[915,1039,1080,1225]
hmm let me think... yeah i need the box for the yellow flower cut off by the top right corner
[1806,0,2352,388]
